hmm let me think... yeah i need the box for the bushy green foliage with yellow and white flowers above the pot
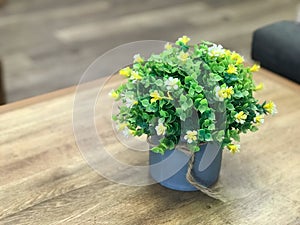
[111,36,271,154]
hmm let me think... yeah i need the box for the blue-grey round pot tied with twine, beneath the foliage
[149,144,222,191]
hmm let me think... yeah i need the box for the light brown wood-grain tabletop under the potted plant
[0,70,300,225]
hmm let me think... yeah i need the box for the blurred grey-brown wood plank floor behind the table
[0,0,300,102]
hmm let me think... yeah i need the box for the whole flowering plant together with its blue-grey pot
[110,36,276,191]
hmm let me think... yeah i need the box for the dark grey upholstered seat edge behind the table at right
[251,21,300,83]
